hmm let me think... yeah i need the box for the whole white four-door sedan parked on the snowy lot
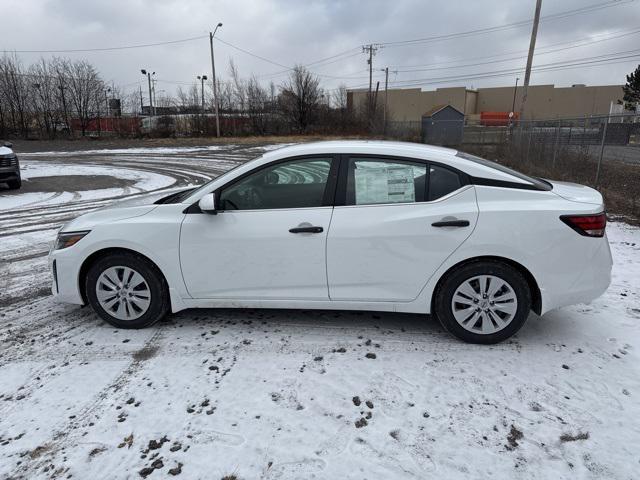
[50,141,612,343]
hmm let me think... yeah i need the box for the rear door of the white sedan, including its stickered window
[327,155,478,301]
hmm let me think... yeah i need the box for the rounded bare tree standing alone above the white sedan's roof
[279,65,322,133]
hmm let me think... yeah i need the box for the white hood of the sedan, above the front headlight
[61,188,184,232]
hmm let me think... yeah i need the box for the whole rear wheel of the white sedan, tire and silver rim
[434,261,531,344]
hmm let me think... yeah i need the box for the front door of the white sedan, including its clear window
[180,156,334,300]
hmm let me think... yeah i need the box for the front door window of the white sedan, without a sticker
[220,157,332,210]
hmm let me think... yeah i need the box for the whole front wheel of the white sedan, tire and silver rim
[85,253,169,328]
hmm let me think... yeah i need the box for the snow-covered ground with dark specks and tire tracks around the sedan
[0,148,640,479]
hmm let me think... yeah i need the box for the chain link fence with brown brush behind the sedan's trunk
[388,114,640,223]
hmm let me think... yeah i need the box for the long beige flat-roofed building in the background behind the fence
[347,85,623,121]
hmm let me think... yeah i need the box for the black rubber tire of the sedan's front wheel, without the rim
[85,252,170,328]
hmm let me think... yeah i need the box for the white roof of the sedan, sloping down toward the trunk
[257,140,529,184]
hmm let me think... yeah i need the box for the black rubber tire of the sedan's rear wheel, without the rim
[434,261,531,344]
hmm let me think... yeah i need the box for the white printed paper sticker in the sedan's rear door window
[355,165,416,205]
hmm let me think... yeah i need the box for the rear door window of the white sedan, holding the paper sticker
[346,157,427,205]
